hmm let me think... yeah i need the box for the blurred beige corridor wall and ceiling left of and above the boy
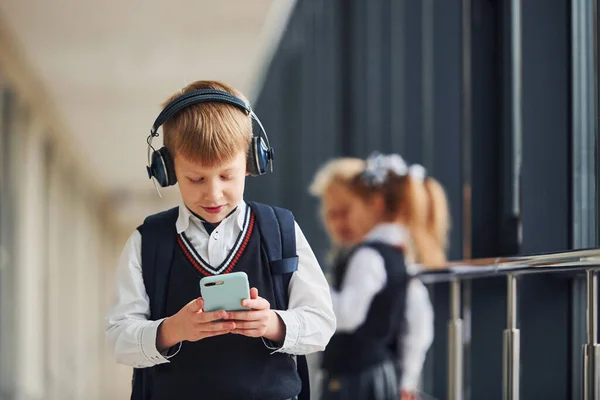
[0,0,293,400]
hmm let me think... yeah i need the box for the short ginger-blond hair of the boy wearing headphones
[163,81,252,167]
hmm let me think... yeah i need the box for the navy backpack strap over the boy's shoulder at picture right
[248,202,310,400]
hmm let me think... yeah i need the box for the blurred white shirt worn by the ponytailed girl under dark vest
[331,224,433,391]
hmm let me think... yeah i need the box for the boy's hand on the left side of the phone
[156,297,236,351]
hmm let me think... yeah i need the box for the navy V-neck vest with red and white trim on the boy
[152,211,301,400]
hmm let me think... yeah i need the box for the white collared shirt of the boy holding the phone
[106,201,335,368]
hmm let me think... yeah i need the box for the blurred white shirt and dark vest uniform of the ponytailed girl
[323,224,433,400]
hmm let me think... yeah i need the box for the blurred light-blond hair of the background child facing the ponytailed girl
[309,157,365,197]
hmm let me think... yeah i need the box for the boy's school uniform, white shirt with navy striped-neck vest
[106,201,335,400]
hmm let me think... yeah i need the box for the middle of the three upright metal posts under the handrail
[502,274,521,400]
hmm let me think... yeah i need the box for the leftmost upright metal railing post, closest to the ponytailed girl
[448,279,463,400]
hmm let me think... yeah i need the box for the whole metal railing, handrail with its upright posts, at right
[418,249,600,400]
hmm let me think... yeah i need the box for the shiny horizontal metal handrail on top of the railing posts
[416,248,600,283]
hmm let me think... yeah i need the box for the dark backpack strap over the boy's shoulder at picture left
[131,207,179,400]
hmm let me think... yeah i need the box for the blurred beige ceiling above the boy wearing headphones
[0,0,295,230]
